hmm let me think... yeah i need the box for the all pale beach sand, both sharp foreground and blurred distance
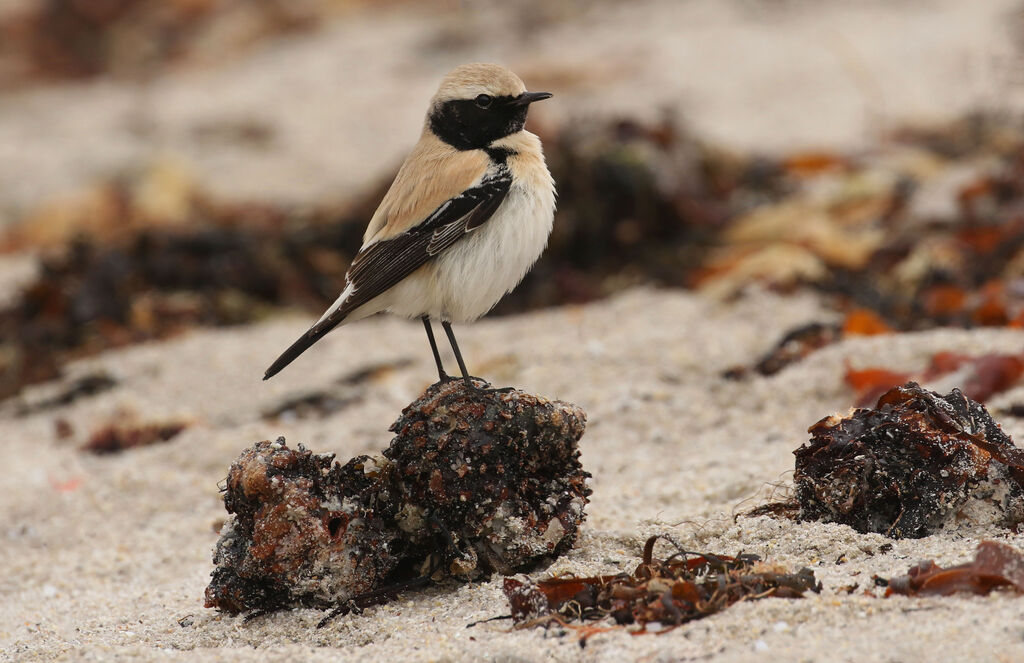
[0,0,1024,663]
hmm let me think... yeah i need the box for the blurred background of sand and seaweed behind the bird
[0,0,1024,398]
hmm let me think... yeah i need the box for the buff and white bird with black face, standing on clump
[263,63,555,390]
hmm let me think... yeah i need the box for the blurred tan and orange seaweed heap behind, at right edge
[698,115,1024,333]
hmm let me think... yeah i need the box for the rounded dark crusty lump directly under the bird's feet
[384,380,590,576]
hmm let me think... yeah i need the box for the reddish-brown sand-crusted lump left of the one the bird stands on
[206,438,397,613]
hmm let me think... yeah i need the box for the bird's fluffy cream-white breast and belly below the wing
[380,185,554,323]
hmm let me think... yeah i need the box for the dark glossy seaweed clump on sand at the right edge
[794,382,1024,538]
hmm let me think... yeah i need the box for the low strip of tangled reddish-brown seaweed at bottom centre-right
[504,536,821,641]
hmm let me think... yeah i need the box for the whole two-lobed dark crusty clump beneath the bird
[206,380,590,614]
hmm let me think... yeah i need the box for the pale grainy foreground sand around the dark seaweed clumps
[6,290,1024,661]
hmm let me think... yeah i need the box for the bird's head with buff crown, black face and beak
[427,64,551,150]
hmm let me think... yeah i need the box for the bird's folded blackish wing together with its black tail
[263,164,512,380]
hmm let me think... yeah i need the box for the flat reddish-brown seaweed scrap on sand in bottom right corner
[886,541,1024,596]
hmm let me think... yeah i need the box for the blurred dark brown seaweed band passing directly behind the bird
[0,116,782,399]
